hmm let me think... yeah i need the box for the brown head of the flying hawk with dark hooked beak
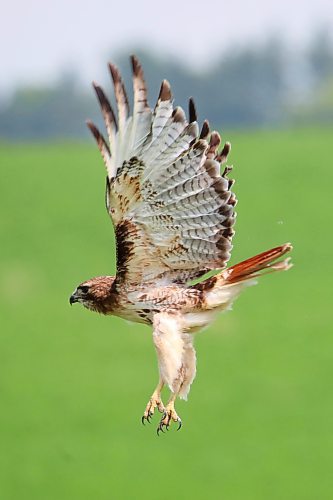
[69,276,115,314]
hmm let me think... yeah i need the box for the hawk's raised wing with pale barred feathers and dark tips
[88,56,236,285]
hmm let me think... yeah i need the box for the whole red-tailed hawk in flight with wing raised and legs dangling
[70,56,292,433]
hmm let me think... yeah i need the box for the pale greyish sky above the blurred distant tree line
[0,0,333,92]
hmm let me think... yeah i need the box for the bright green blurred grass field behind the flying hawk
[0,129,333,500]
